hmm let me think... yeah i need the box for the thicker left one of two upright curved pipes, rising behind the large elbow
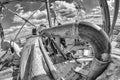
[98,0,110,35]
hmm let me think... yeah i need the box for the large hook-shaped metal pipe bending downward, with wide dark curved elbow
[40,22,111,80]
